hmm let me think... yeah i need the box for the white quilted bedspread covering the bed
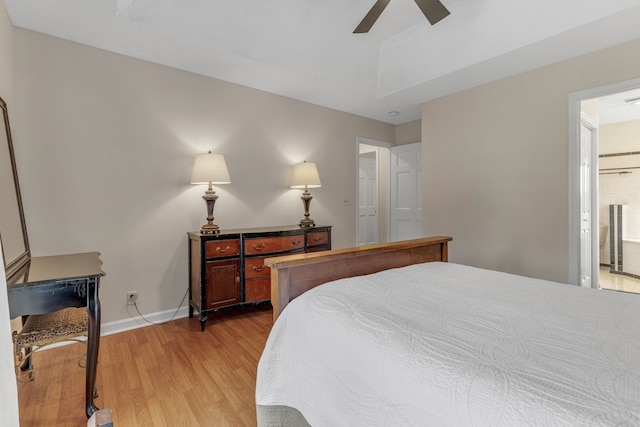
[256,263,640,427]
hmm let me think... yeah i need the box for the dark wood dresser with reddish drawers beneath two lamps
[187,225,331,331]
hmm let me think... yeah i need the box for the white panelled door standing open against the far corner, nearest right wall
[389,142,422,241]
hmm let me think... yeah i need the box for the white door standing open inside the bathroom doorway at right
[580,115,599,288]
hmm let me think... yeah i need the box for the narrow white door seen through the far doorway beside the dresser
[358,149,379,246]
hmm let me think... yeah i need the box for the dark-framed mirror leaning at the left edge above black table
[0,98,30,280]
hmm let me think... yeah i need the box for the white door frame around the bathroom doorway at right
[568,78,640,285]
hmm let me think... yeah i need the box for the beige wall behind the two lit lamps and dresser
[14,29,394,322]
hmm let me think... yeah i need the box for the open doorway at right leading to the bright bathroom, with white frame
[569,79,640,292]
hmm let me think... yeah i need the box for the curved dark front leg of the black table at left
[85,278,100,418]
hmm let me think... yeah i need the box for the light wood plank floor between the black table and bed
[17,304,272,427]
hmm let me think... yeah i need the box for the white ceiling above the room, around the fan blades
[4,0,640,124]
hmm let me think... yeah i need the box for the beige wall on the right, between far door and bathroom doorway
[422,40,640,282]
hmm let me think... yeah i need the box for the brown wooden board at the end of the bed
[264,236,452,321]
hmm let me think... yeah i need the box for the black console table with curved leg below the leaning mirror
[7,252,105,417]
